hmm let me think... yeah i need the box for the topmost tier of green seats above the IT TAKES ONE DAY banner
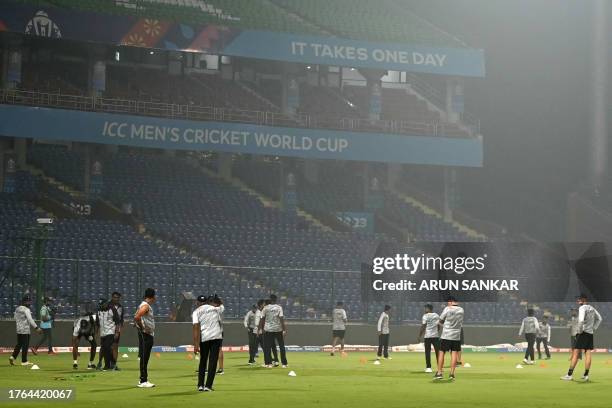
[16,0,467,48]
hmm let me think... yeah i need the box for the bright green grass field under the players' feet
[0,353,612,408]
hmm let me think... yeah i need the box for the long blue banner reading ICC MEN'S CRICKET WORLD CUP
[0,104,483,167]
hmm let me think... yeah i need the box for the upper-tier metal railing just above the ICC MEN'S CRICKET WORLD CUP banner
[0,89,469,137]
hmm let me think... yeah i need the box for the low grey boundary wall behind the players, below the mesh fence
[0,321,612,348]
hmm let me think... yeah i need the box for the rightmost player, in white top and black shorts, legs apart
[561,295,602,381]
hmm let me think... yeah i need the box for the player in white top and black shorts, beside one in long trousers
[434,296,464,381]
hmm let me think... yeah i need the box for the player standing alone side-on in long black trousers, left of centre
[134,288,156,388]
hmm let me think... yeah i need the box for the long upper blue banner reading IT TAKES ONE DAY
[0,1,485,77]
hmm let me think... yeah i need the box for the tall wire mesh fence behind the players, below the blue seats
[0,255,584,325]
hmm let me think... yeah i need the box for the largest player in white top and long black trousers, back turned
[193,295,225,392]
